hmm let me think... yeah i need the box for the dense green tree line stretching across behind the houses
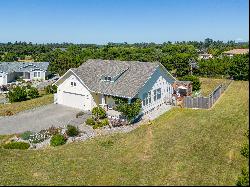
[0,38,249,80]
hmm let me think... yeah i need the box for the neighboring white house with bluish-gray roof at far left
[0,62,49,86]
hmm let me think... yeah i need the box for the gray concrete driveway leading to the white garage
[0,104,89,134]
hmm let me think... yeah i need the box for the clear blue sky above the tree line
[0,0,249,44]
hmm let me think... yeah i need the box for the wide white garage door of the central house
[60,92,90,110]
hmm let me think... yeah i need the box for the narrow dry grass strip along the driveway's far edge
[0,94,54,116]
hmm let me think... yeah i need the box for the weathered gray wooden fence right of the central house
[183,81,232,109]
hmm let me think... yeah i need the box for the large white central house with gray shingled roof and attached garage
[54,59,176,114]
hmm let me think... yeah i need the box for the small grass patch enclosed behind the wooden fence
[200,78,230,96]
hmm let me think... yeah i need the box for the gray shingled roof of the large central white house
[71,59,159,98]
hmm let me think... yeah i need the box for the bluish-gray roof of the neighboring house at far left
[0,62,49,73]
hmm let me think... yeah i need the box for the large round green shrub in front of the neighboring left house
[7,86,27,103]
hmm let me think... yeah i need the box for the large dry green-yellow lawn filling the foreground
[0,82,249,185]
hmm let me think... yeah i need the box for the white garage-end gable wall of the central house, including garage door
[57,75,94,110]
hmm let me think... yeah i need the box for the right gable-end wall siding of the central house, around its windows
[137,68,173,114]
